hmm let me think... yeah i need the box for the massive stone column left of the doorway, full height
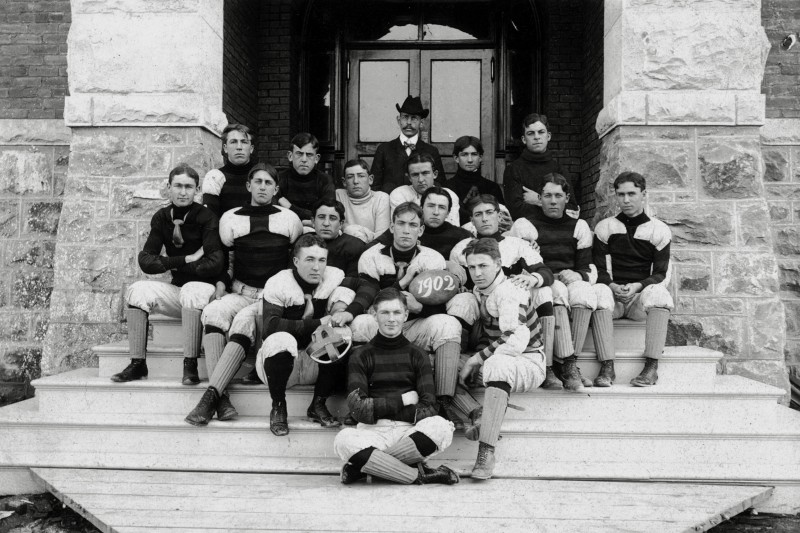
[42,0,226,374]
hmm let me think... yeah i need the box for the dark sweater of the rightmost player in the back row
[503,149,577,220]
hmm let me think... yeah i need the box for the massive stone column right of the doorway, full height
[595,0,788,389]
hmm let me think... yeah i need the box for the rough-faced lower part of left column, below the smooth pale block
[42,127,221,374]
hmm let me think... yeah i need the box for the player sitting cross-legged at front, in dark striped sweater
[333,288,458,485]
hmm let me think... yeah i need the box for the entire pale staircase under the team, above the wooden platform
[0,317,800,512]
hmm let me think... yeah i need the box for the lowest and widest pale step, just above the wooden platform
[0,399,800,484]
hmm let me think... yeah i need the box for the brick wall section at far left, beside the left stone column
[0,0,70,119]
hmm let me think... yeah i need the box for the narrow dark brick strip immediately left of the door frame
[257,0,295,165]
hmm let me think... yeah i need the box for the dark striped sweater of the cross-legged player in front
[347,333,436,424]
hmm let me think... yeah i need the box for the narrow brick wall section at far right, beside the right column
[761,0,800,118]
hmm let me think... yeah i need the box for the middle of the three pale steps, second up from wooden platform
[33,368,784,423]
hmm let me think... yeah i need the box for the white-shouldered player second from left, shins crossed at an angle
[186,163,303,425]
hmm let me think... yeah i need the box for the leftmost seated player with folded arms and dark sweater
[111,163,225,385]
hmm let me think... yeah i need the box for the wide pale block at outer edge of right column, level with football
[714,252,778,297]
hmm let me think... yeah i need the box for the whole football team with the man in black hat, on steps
[111,96,673,484]
